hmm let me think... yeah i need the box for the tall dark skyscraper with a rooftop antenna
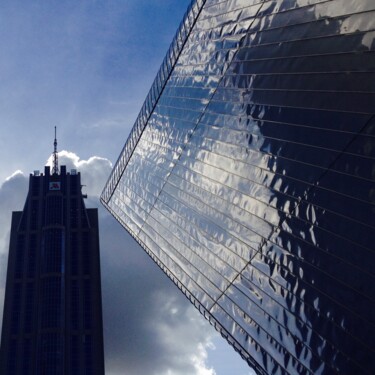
[0,135,104,375]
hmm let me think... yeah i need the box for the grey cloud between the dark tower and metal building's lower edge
[100,209,214,375]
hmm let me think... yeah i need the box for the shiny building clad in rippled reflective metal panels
[102,0,375,374]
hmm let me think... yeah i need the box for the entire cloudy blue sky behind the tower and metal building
[0,0,253,375]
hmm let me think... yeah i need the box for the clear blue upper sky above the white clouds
[0,0,188,178]
